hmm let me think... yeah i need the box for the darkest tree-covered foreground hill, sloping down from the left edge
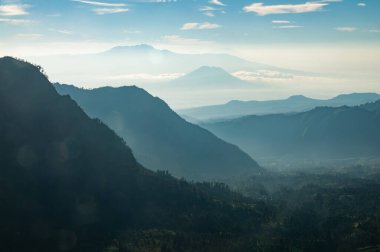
[0,57,263,251]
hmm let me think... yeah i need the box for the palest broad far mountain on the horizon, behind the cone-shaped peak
[28,44,299,86]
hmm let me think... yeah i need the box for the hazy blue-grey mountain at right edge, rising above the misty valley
[202,102,380,163]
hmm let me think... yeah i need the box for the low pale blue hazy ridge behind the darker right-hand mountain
[177,93,380,121]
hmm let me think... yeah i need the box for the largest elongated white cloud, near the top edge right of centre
[243,1,330,16]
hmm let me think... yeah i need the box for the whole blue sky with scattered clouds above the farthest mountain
[0,0,380,106]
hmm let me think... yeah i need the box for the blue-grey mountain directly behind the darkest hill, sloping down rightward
[55,84,260,180]
